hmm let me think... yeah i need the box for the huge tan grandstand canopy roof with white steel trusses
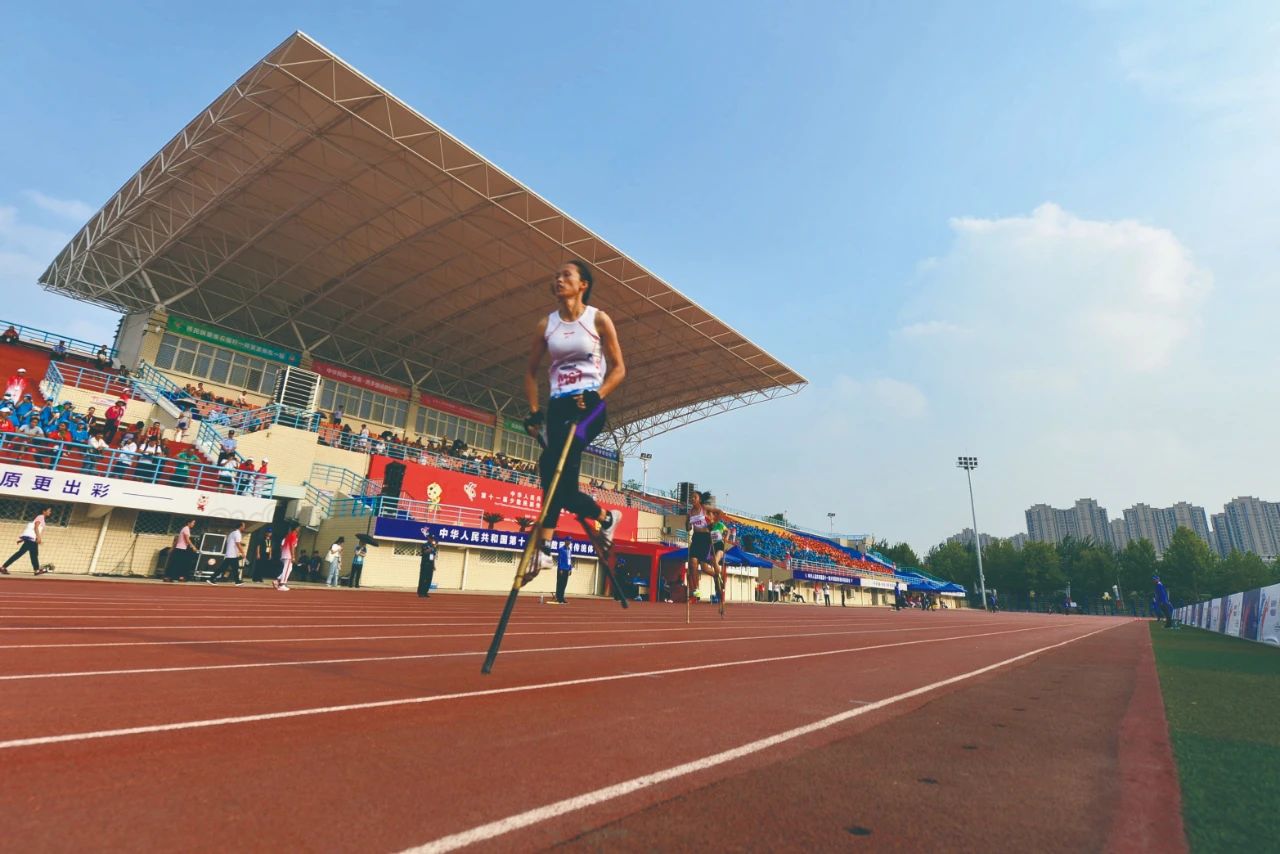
[41,33,805,447]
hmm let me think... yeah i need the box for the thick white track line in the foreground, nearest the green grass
[404,624,1119,854]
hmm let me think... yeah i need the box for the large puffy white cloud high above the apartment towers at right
[901,204,1212,376]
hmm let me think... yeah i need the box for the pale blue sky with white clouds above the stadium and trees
[0,1,1280,549]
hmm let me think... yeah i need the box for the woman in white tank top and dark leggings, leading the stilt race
[524,259,627,584]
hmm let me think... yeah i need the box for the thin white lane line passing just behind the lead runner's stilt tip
[0,629,1008,682]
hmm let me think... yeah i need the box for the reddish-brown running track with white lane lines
[0,579,1176,851]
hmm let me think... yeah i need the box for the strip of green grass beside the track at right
[1151,622,1280,854]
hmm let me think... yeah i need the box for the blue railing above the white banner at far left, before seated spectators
[0,433,275,501]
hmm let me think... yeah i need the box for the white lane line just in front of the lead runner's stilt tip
[0,626,1059,750]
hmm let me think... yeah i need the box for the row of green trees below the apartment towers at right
[916,528,1280,604]
